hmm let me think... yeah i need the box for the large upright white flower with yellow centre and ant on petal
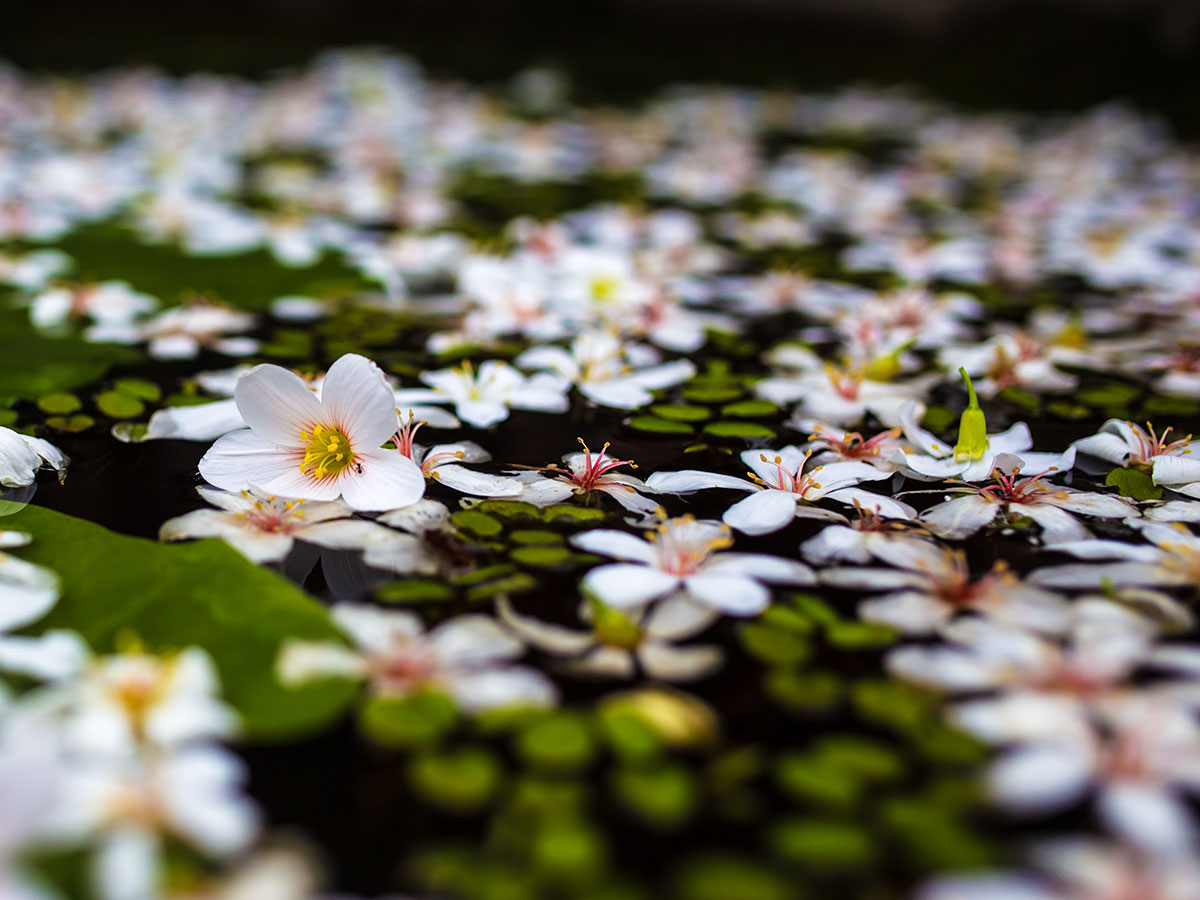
[200,354,425,518]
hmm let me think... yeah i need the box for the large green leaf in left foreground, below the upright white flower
[5,506,356,738]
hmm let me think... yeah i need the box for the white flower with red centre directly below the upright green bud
[920,455,1138,545]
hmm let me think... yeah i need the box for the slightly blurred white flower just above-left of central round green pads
[516,331,696,409]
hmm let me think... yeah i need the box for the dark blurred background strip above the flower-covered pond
[7,0,1200,138]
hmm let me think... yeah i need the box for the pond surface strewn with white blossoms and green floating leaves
[0,47,1200,900]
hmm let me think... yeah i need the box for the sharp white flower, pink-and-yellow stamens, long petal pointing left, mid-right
[646,445,916,534]
